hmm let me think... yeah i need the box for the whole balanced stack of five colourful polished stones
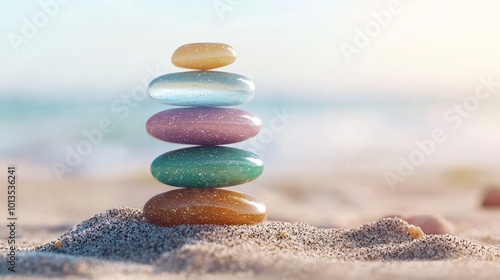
[143,43,267,226]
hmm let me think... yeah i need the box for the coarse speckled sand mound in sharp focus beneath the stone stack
[34,208,499,264]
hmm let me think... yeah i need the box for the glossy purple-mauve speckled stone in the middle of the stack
[146,107,262,145]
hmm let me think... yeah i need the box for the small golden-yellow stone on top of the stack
[172,43,236,70]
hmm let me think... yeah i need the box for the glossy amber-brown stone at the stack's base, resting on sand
[143,189,267,226]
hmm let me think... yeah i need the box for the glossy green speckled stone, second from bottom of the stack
[151,146,264,188]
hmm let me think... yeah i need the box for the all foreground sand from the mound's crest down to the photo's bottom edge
[0,207,500,279]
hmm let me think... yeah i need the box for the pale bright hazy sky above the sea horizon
[0,0,500,98]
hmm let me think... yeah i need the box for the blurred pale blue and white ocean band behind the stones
[0,95,500,179]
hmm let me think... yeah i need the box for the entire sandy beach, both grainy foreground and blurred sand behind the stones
[1,165,500,279]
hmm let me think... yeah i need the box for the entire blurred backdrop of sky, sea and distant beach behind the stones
[0,0,500,234]
